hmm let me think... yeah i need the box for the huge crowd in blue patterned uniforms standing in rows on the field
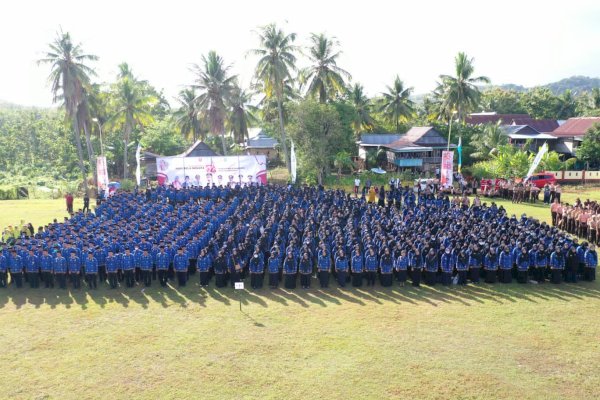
[0,185,599,290]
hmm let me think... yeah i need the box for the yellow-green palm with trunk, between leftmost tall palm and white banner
[110,68,156,179]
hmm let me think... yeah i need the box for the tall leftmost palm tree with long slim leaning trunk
[38,32,98,192]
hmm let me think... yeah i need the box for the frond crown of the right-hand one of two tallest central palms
[301,33,351,103]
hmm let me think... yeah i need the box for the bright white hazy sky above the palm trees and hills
[0,0,600,107]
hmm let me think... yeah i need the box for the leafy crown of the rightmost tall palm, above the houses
[437,52,490,121]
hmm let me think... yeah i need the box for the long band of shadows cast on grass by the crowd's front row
[0,279,600,310]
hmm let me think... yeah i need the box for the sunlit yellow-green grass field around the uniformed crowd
[0,186,600,399]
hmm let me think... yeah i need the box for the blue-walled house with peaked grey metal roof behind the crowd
[383,126,456,171]
